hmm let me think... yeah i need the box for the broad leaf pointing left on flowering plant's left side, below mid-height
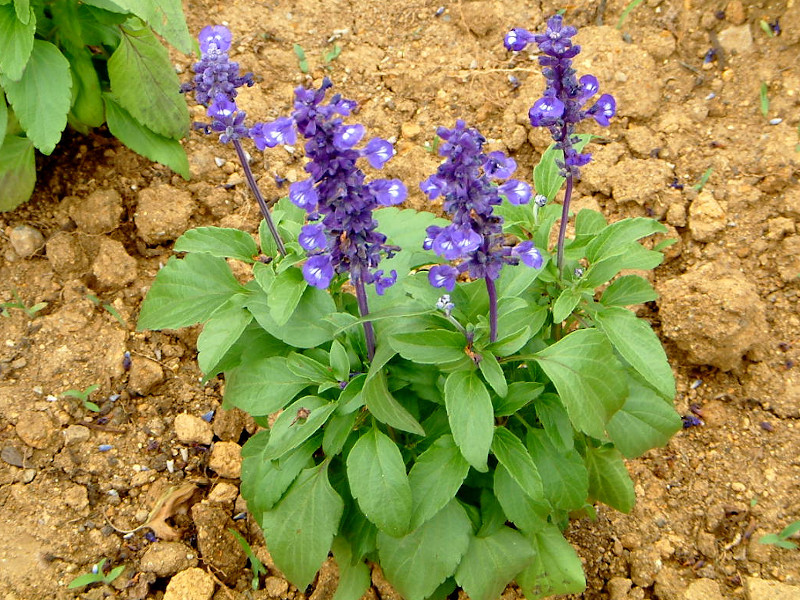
[224,356,308,417]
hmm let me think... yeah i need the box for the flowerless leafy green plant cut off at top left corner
[0,0,195,211]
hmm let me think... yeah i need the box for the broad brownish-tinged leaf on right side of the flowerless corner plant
[107,22,189,140]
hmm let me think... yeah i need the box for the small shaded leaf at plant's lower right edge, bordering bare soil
[584,446,636,513]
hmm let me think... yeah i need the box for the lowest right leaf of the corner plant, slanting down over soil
[103,93,189,179]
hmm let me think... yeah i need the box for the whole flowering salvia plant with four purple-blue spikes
[139,17,681,600]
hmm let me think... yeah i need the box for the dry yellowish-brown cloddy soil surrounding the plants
[0,0,800,600]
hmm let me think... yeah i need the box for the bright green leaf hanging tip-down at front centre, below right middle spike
[444,371,494,473]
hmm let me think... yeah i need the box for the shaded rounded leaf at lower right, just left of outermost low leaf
[526,429,589,511]
